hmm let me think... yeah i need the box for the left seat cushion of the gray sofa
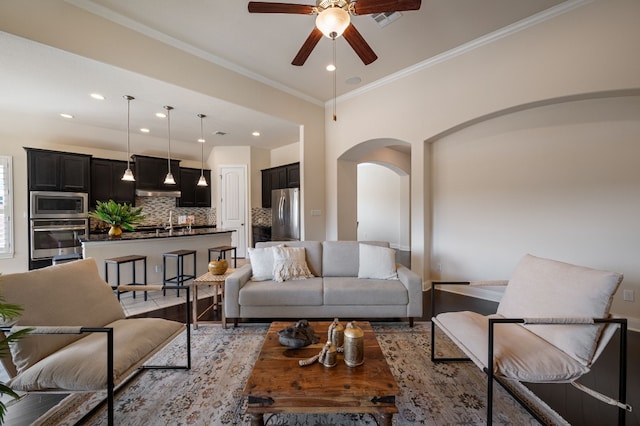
[238,278,323,306]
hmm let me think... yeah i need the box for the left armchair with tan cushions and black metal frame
[0,258,191,425]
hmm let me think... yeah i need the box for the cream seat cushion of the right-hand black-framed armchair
[435,311,589,383]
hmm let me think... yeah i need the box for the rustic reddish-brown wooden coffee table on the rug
[242,321,399,426]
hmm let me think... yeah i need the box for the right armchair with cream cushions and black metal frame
[431,255,631,425]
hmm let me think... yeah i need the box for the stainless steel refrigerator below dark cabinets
[271,188,300,241]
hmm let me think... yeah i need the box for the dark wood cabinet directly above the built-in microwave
[25,148,91,192]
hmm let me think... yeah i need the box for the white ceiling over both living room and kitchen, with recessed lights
[0,0,576,160]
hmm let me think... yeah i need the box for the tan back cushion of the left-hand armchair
[0,258,125,372]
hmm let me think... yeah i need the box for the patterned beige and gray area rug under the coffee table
[37,322,566,426]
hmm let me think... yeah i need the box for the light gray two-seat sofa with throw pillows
[224,241,422,326]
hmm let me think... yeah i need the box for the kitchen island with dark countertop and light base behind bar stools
[80,227,235,284]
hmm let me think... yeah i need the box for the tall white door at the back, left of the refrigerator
[219,166,248,257]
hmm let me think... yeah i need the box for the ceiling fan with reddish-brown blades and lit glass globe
[249,0,421,66]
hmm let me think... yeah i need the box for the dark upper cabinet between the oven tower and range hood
[89,158,137,209]
